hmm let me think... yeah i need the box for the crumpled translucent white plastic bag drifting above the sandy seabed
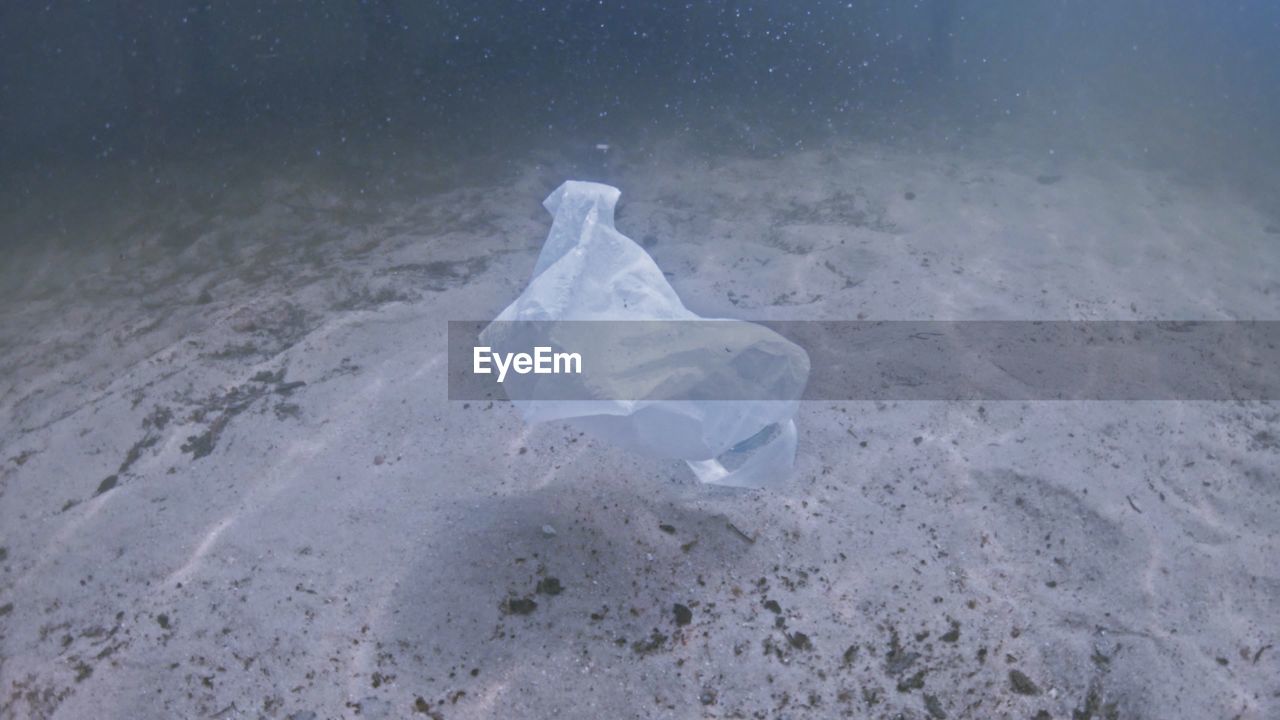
[480,181,809,487]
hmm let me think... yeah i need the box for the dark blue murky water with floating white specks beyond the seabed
[0,0,1280,198]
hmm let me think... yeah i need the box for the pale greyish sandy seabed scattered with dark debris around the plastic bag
[0,131,1280,720]
